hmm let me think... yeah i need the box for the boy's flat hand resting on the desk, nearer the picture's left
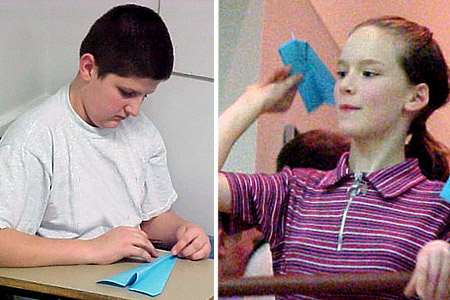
[88,227,158,264]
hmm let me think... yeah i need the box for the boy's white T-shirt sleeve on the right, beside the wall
[142,139,177,221]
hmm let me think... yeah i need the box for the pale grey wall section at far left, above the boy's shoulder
[0,0,47,135]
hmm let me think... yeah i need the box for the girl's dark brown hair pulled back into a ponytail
[353,16,449,181]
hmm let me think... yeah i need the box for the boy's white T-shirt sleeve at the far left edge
[0,144,51,234]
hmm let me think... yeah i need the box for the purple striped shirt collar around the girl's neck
[320,152,426,198]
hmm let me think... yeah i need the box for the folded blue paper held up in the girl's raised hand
[278,40,335,113]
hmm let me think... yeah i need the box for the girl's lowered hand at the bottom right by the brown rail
[405,240,450,300]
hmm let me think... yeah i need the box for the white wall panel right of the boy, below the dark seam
[142,76,214,234]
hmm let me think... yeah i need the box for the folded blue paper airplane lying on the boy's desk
[97,253,177,297]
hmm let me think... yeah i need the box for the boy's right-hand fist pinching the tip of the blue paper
[171,222,211,260]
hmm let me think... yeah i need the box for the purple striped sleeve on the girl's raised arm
[223,168,291,241]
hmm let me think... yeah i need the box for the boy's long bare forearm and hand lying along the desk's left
[0,227,158,267]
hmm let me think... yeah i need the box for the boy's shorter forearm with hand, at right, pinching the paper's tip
[141,211,211,260]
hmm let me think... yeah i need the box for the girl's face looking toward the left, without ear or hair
[334,26,414,137]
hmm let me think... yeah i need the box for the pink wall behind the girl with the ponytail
[256,0,450,173]
